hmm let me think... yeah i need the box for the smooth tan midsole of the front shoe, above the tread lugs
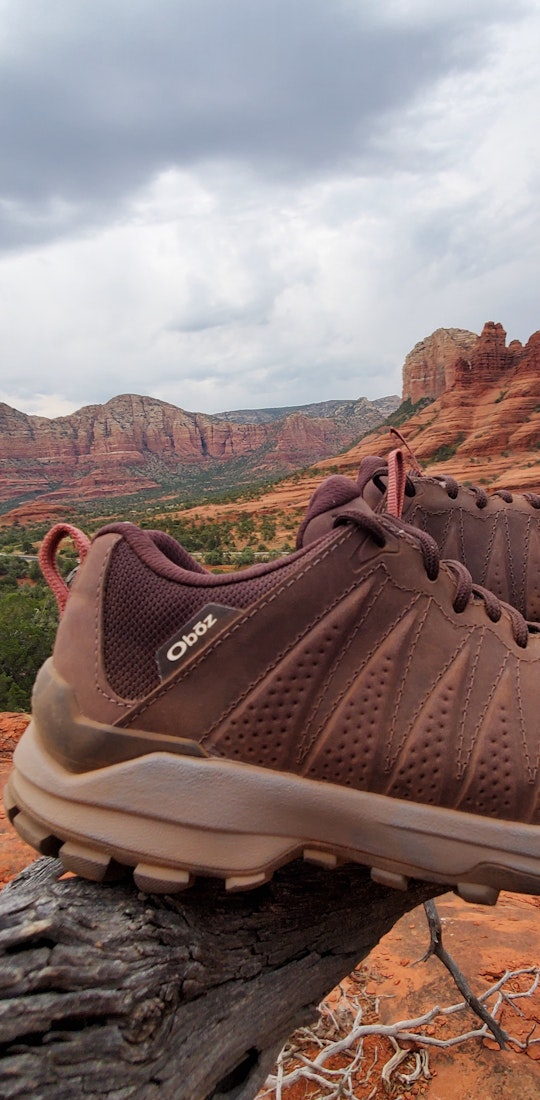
[12,724,540,890]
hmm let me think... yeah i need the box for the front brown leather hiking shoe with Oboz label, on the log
[5,499,540,903]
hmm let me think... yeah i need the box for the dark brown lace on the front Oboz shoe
[334,509,529,649]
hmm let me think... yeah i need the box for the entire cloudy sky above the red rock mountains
[0,0,540,416]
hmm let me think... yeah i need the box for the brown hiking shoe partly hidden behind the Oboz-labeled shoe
[354,452,540,622]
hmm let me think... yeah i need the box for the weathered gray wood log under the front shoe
[0,859,445,1100]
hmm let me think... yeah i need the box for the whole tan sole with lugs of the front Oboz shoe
[4,723,540,904]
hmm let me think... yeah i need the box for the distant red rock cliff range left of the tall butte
[0,394,399,512]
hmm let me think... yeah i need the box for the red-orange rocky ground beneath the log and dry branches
[0,714,540,1100]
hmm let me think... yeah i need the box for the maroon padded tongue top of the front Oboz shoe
[296,455,385,550]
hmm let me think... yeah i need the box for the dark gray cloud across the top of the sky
[0,0,523,248]
